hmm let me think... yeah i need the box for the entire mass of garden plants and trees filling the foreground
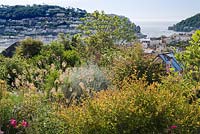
[0,12,200,134]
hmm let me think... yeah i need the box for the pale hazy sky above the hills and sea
[0,0,200,21]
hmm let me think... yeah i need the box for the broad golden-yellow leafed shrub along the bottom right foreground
[64,76,200,134]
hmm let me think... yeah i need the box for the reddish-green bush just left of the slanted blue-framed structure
[108,44,166,87]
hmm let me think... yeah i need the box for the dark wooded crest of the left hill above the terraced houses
[0,5,86,20]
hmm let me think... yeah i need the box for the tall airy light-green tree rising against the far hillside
[80,11,135,58]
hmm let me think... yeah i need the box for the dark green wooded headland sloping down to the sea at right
[168,14,200,32]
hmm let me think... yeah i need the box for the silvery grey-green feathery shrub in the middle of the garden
[61,65,109,103]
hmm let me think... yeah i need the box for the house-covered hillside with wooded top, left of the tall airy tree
[0,5,87,36]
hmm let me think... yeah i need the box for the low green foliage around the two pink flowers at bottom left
[0,92,68,134]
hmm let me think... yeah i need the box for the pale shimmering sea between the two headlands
[135,21,178,38]
